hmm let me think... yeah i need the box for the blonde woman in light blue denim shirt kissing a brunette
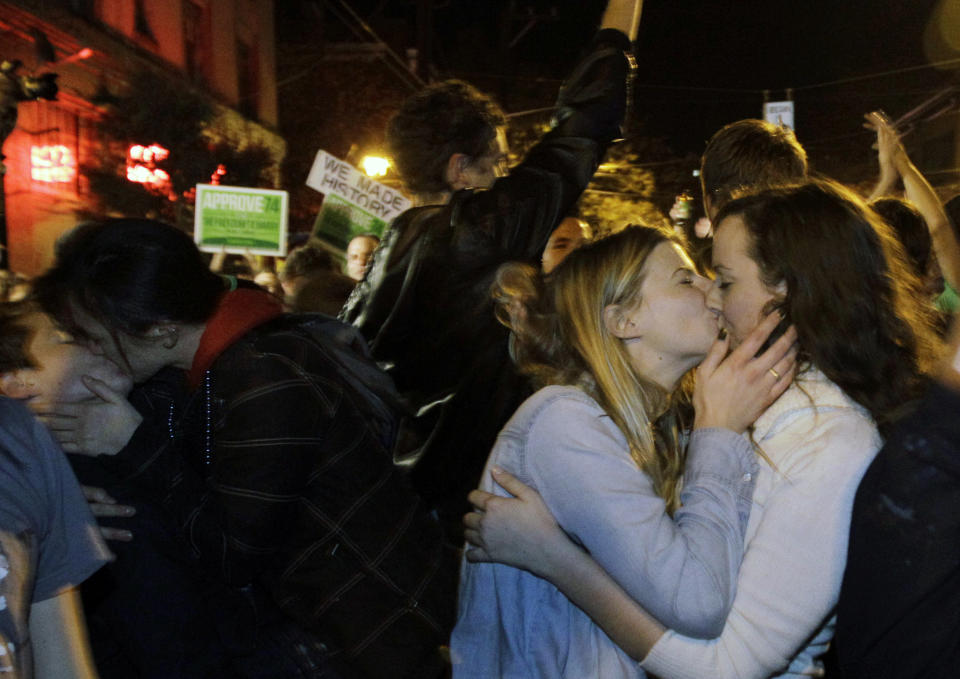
[451,227,795,679]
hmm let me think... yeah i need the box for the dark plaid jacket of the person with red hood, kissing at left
[105,314,457,679]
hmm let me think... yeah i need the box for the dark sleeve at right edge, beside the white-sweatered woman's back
[836,385,960,679]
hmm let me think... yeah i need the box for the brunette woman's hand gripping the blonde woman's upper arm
[463,468,573,579]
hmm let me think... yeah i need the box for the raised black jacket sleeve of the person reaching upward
[452,29,635,260]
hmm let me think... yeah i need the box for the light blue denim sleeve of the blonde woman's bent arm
[526,399,756,637]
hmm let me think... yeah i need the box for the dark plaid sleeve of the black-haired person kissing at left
[108,355,342,585]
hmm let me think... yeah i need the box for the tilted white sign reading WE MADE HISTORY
[307,151,411,222]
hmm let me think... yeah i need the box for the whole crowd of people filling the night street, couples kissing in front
[0,0,960,679]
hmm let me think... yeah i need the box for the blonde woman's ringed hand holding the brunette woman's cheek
[693,312,797,433]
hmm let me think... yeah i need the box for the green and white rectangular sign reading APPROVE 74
[193,184,287,257]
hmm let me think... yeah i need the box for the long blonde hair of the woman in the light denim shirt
[493,226,687,512]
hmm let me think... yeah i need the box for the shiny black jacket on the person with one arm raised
[341,29,633,527]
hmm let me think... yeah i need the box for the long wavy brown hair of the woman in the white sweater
[716,180,940,429]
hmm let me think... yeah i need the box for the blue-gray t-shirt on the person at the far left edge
[0,397,110,679]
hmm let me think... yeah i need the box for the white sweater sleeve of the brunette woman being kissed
[641,411,879,679]
